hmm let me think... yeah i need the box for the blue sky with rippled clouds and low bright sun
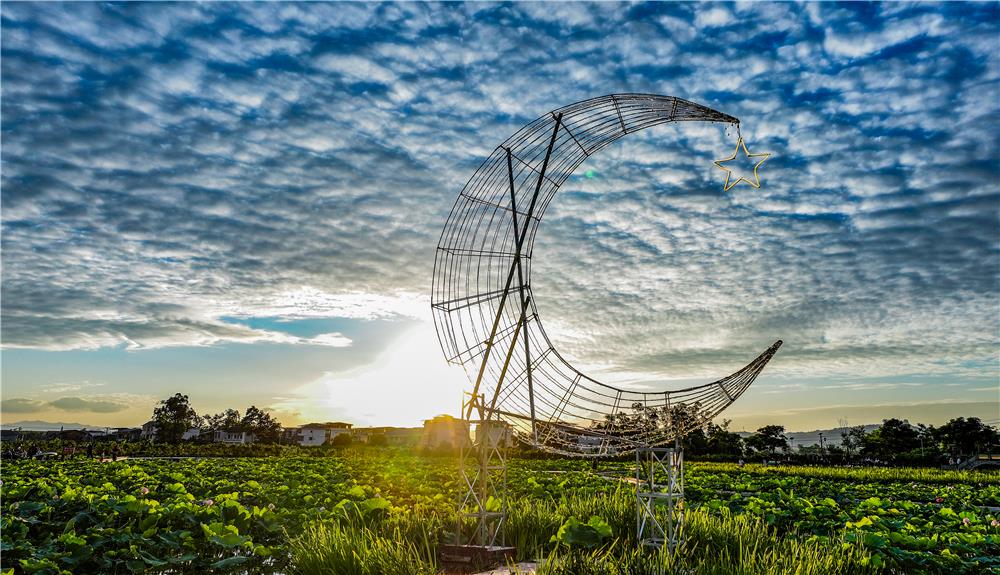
[0,2,1000,430]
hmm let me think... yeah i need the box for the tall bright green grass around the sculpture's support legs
[290,488,879,575]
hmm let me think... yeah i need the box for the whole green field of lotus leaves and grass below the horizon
[0,449,1000,574]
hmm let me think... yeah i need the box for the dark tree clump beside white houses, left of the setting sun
[152,393,281,443]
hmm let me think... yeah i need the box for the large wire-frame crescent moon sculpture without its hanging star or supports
[431,94,781,457]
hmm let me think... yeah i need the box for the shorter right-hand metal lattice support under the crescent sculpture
[635,447,684,552]
